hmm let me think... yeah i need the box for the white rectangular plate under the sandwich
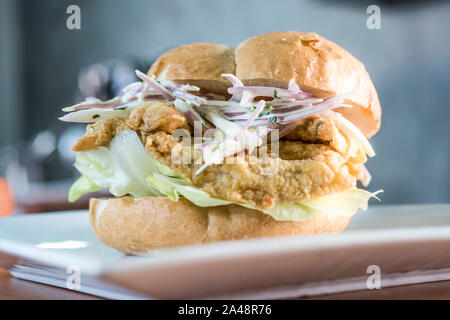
[0,205,450,298]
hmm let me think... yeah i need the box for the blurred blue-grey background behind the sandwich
[0,0,450,208]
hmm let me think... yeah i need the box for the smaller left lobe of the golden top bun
[148,43,236,94]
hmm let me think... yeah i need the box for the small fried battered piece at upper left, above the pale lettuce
[72,102,186,152]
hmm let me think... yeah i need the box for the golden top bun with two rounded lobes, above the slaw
[149,31,381,138]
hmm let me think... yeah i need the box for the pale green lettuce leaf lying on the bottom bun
[69,131,378,221]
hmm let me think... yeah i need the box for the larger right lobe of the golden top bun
[236,31,381,137]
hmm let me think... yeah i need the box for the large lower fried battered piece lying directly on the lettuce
[145,132,356,209]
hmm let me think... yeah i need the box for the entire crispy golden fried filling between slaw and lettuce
[73,102,367,209]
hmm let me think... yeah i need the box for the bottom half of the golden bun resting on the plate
[90,197,350,254]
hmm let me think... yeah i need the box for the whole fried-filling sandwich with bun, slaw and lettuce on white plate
[60,32,381,255]
